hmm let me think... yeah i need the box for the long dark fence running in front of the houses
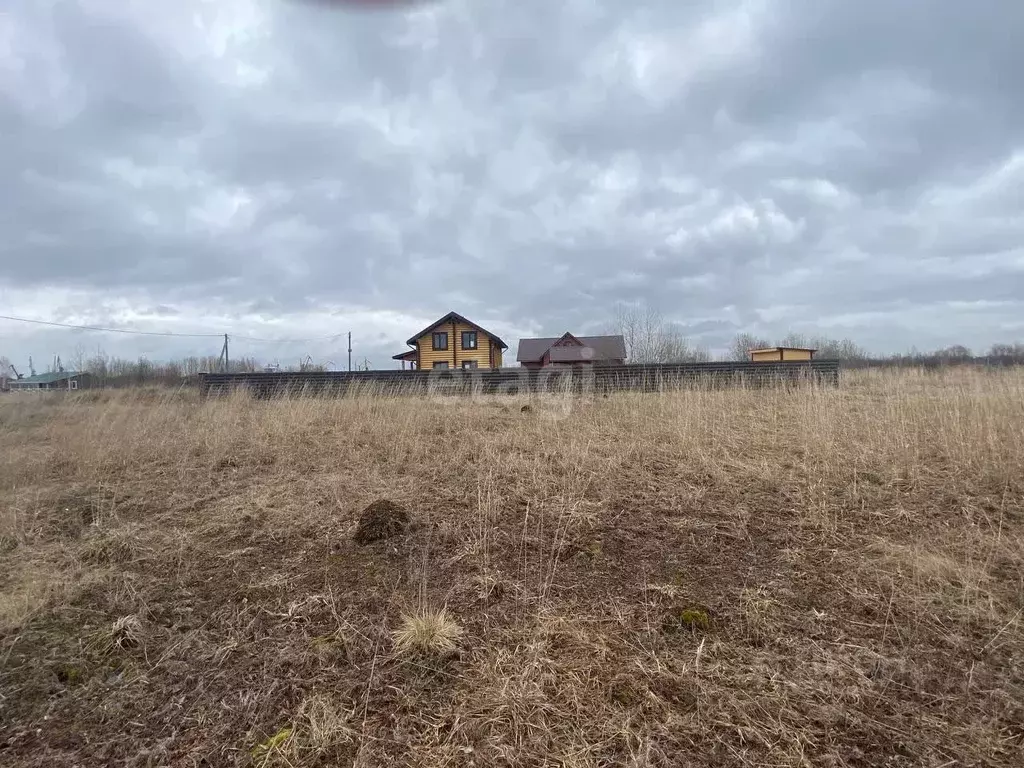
[199,360,840,397]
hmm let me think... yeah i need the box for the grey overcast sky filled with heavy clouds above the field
[0,0,1024,368]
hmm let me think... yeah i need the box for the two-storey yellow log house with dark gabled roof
[393,312,508,371]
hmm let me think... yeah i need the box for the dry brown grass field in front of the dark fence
[0,371,1024,768]
